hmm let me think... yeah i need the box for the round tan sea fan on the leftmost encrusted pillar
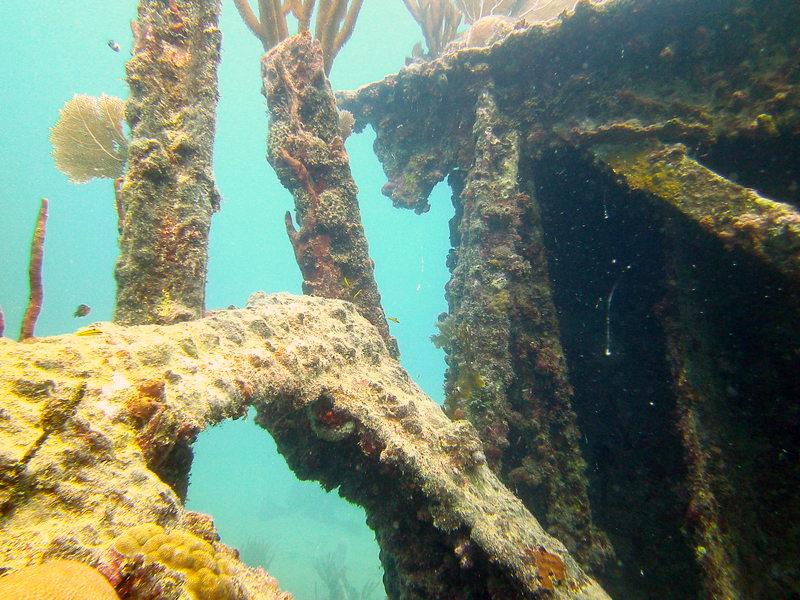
[50,94,128,183]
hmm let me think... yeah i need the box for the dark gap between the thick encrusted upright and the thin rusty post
[523,149,700,599]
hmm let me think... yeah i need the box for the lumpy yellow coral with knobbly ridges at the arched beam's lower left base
[113,523,238,600]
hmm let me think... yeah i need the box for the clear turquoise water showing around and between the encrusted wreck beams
[0,0,452,600]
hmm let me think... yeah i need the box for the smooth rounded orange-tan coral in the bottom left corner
[0,559,119,600]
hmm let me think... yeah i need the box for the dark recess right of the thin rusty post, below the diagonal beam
[674,212,800,599]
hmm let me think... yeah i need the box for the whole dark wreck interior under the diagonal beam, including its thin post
[522,148,800,599]
